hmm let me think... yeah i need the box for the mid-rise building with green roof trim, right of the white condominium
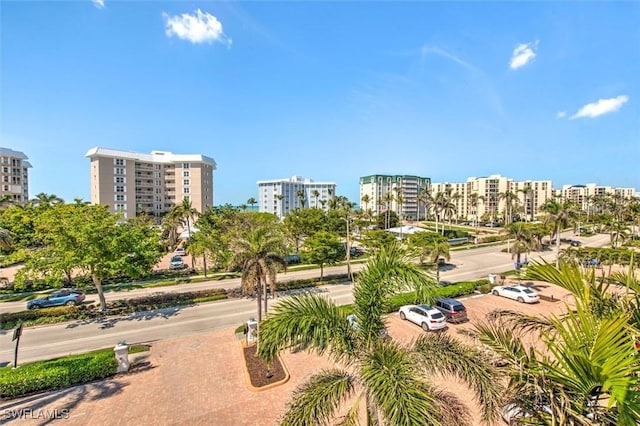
[359,175,431,220]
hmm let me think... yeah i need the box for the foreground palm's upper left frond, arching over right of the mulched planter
[258,294,356,362]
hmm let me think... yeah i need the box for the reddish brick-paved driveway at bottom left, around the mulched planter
[0,329,331,426]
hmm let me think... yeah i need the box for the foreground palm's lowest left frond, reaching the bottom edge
[281,370,356,426]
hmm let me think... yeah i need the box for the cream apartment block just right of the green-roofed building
[431,175,553,221]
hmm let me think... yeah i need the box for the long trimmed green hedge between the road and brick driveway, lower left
[0,349,118,398]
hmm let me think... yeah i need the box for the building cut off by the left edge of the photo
[0,147,31,206]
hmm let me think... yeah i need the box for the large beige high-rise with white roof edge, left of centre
[85,147,216,219]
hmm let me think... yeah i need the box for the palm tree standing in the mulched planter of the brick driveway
[232,225,287,326]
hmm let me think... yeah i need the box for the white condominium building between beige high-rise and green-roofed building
[258,176,336,219]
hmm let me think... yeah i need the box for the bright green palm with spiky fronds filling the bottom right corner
[476,263,640,425]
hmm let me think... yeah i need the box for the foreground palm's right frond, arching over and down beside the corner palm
[413,333,504,422]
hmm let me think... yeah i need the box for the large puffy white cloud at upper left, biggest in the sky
[162,9,231,46]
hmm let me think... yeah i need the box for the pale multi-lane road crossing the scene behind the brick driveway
[0,231,609,363]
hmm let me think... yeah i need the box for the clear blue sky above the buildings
[0,0,640,204]
